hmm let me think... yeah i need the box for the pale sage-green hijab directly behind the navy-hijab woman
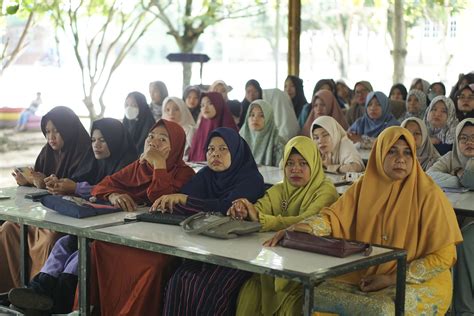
[239,100,283,166]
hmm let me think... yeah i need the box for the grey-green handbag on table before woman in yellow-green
[181,212,262,239]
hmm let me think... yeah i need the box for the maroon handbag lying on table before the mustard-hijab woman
[279,230,372,258]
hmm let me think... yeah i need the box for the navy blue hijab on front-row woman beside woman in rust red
[181,127,265,214]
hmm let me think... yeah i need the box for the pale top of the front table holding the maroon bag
[87,222,404,282]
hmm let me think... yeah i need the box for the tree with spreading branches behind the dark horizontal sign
[142,0,264,87]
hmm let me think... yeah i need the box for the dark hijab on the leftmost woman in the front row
[35,106,94,179]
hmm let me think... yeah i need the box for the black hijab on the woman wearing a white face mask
[123,91,155,155]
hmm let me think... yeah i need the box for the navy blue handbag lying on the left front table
[41,195,121,218]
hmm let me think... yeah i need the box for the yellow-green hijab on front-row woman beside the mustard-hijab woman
[255,136,338,223]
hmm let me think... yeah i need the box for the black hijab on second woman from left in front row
[75,118,138,185]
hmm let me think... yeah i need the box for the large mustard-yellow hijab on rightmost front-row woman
[322,126,462,283]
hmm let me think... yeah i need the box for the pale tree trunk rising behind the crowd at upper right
[392,0,407,84]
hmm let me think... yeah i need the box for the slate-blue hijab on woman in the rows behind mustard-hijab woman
[349,91,400,137]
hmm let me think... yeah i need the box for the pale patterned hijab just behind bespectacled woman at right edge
[423,95,458,144]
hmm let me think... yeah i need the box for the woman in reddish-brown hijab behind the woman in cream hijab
[301,90,349,137]
